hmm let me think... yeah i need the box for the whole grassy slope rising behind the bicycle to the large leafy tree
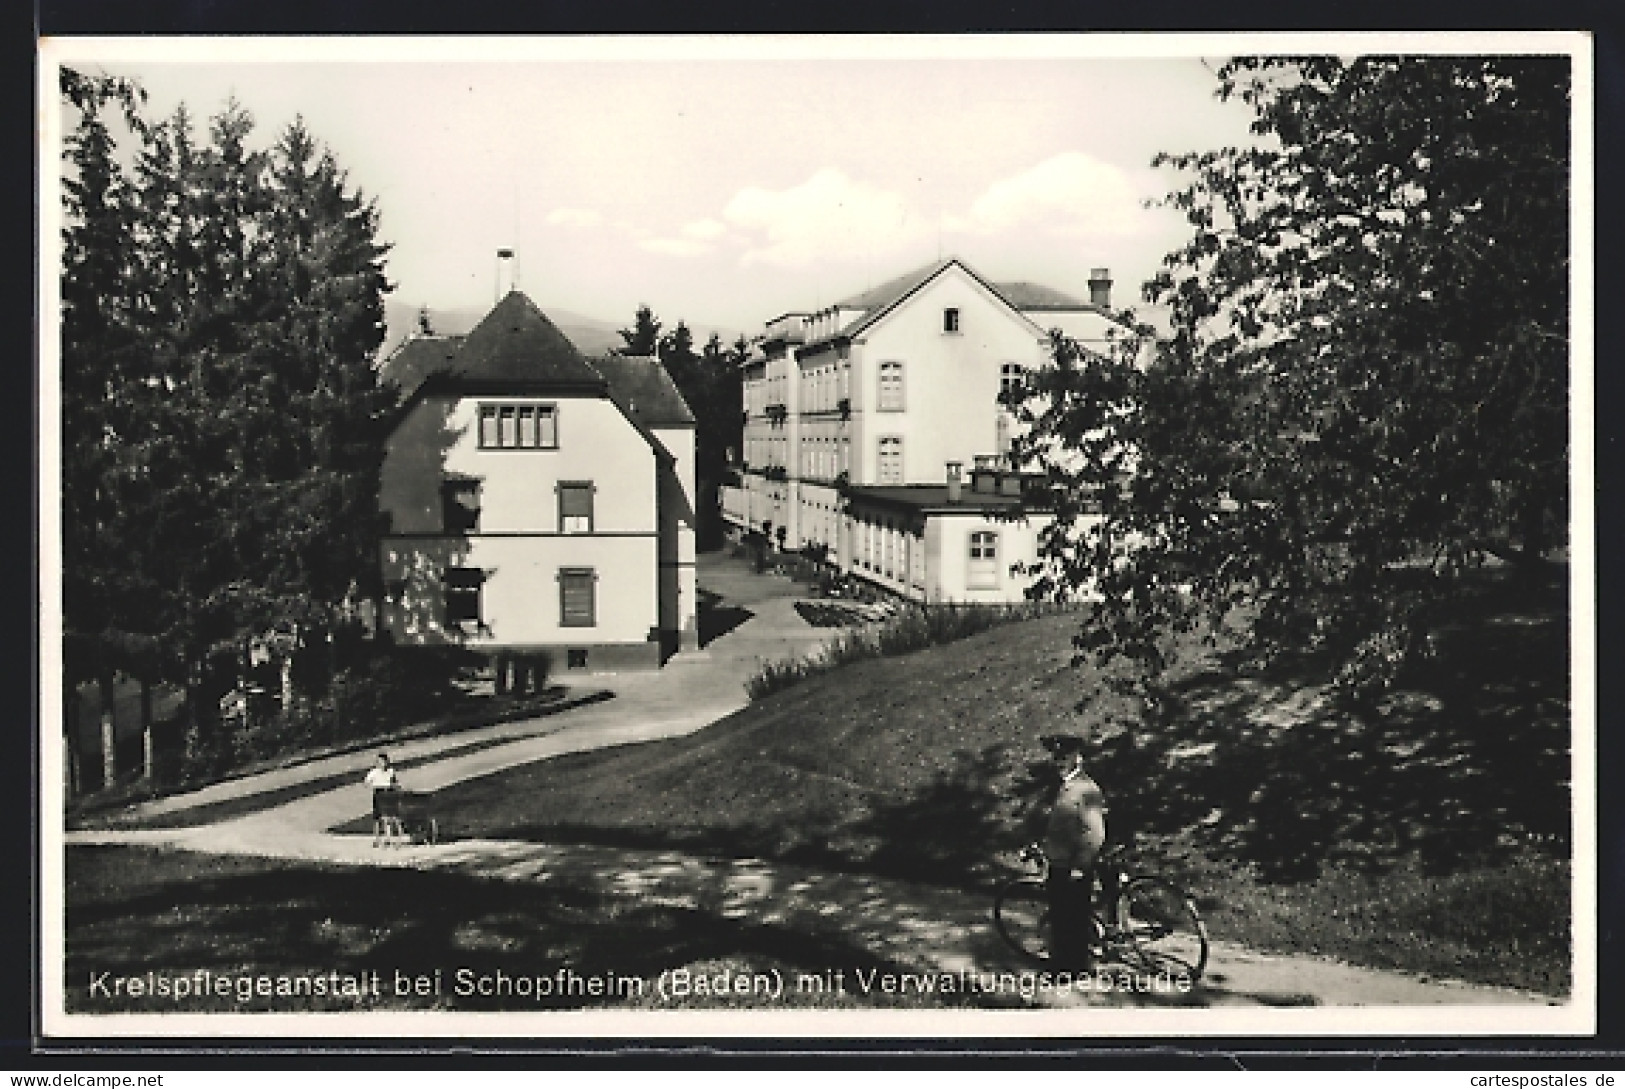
[409,572,1570,995]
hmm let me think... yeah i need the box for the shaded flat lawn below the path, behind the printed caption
[65,847,988,1013]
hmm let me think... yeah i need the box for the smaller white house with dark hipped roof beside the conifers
[379,291,699,671]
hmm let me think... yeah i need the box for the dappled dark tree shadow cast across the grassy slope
[449,572,1570,886]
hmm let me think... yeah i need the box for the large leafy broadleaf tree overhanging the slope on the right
[1019,57,1570,696]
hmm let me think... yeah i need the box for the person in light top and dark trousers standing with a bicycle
[1043,735,1107,969]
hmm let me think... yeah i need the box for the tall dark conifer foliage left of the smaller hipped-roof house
[62,70,398,776]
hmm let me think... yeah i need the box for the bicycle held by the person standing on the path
[993,844,1207,985]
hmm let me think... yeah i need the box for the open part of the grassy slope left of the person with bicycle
[425,618,1124,876]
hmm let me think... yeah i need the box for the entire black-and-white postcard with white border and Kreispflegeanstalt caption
[37,33,1597,1040]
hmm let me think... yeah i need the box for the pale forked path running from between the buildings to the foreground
[67,564,1549,1006]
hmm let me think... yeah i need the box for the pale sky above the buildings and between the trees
[50,36,1251,340]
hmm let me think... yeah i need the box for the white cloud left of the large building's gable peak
[723,167,931,268]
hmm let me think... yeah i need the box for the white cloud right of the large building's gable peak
[944,151,1142,234]
